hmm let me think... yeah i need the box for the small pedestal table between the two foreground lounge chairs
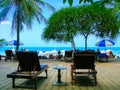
[53,66,67,86]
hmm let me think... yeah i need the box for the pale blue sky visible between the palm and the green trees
[0,0,120,47]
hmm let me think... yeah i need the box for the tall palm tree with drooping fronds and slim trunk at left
[0,0,55,50]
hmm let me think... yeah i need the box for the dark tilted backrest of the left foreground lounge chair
[16,51,41,72]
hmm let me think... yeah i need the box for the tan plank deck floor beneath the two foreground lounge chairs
[0,59,120,90]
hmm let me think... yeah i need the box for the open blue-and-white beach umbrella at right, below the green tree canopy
[95,39,115,51]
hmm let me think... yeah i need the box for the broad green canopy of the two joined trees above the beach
[42,3,119,50]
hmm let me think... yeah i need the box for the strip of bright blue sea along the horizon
[0,46,120,55]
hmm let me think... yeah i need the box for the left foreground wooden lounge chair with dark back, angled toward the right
[7,51,48,90]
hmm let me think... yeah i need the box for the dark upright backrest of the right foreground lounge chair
[73,51,95,69]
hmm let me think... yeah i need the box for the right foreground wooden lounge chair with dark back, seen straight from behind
[71,51,97,84]
